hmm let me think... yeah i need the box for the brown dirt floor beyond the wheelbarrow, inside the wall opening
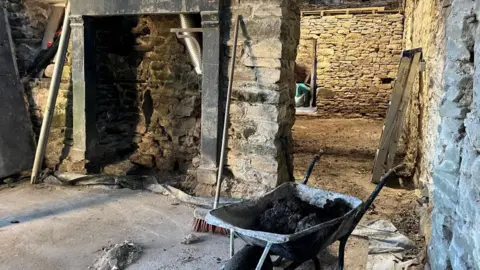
[293,116,424,254]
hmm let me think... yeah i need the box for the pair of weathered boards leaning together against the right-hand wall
[372,49,422,183]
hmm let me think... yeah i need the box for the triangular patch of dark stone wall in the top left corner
[0,0,51,74]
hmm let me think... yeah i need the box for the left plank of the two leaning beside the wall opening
[372,57,411,183]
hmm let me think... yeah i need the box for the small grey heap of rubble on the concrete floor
[93,241,142,270]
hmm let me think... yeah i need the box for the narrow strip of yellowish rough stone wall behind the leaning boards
[402,0,446,253]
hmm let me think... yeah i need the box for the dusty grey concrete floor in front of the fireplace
[0,184,367,270]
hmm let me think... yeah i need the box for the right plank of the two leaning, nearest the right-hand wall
[385,52,422,170]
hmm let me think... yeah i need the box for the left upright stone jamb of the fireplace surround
[69,16,96,166]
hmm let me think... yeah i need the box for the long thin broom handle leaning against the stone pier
[213,16,240,209]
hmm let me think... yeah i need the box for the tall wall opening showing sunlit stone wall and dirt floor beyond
[293,1,424,260]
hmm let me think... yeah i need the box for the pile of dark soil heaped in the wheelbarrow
[253,197,352,234]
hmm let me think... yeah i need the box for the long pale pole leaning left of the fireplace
[30,2,70,184]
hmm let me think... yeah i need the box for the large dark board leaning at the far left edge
[0,8,35,178]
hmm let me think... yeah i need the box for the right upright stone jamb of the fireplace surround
[197,11,223,185]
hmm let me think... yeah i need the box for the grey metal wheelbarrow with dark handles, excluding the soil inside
[205,162,402,270]
